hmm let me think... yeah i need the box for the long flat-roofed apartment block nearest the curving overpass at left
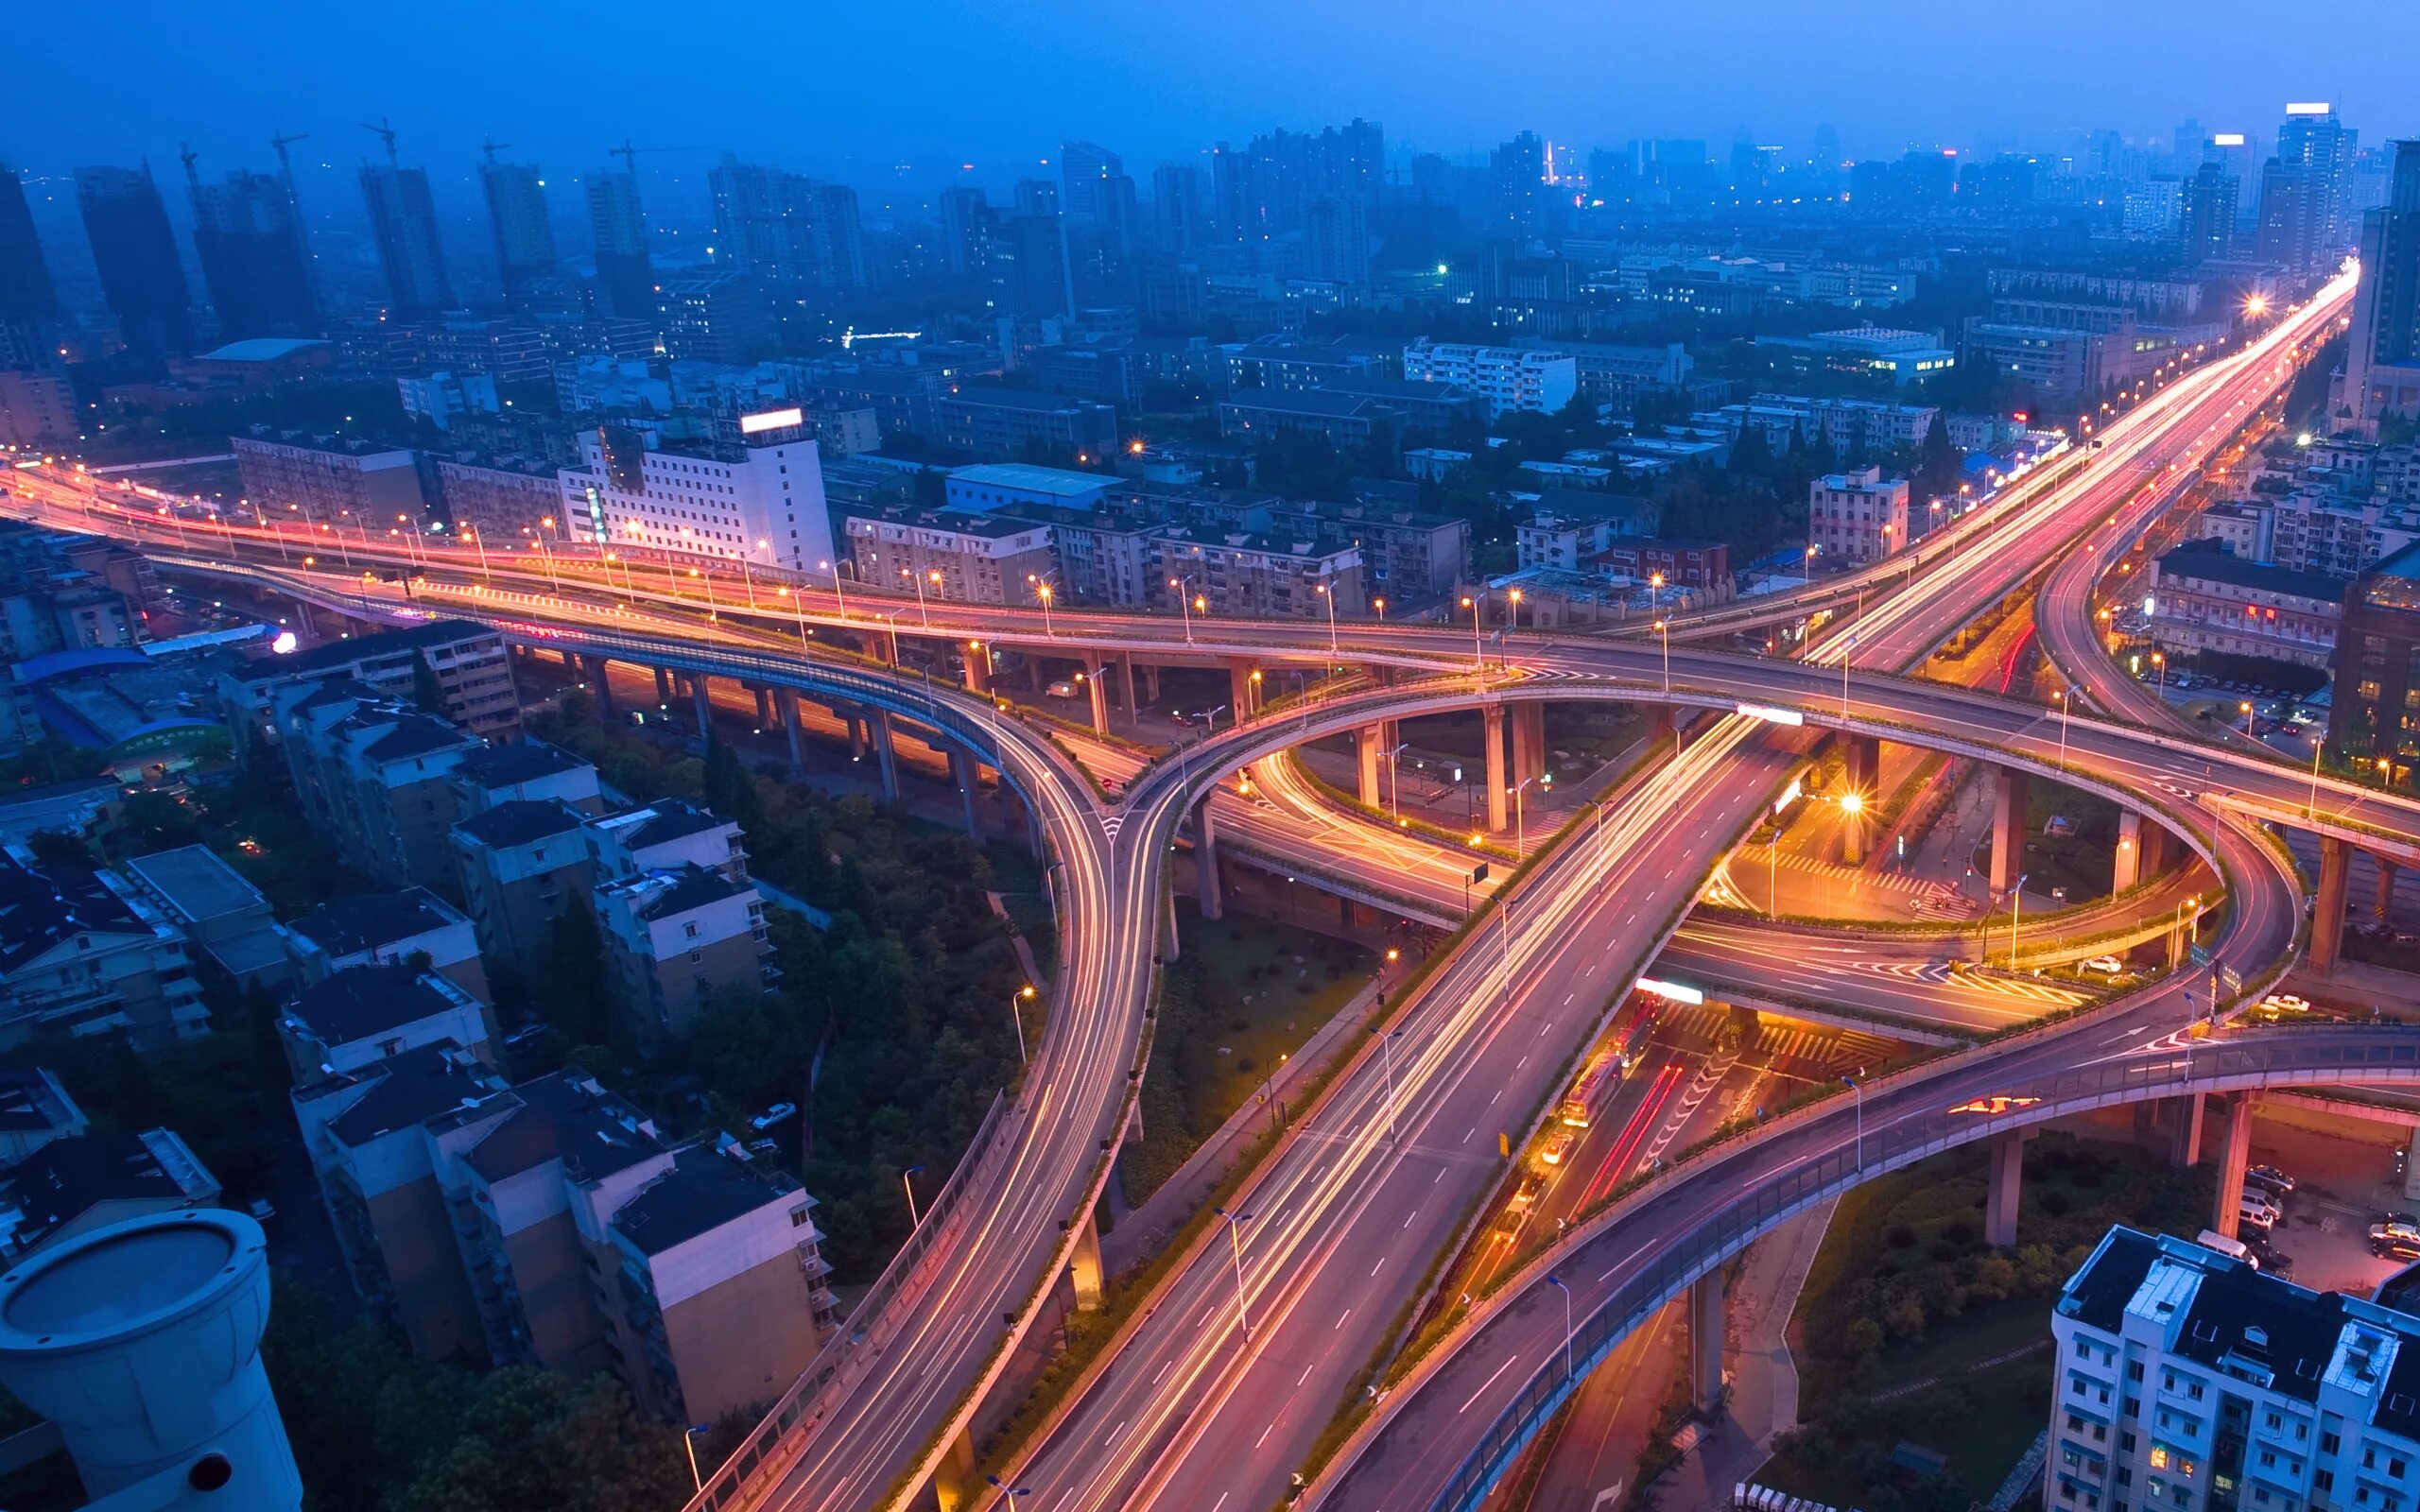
[217,619,520,747]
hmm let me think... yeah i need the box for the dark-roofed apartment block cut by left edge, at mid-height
[0,844,211,1047]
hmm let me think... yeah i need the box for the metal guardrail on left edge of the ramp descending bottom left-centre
[683,1091,1016,1512]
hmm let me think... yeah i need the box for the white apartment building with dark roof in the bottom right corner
[2043,1228,2420,1512]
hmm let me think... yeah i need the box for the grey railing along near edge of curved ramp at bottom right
[1430,1028,2420,1512]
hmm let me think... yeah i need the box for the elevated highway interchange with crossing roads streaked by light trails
[12,265,2420,1512]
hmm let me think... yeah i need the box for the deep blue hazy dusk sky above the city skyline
[19,0,2420,194]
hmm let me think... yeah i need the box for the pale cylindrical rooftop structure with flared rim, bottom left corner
[0,1207,302,1512]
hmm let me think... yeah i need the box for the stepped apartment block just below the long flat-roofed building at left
[276,682,487,885]
